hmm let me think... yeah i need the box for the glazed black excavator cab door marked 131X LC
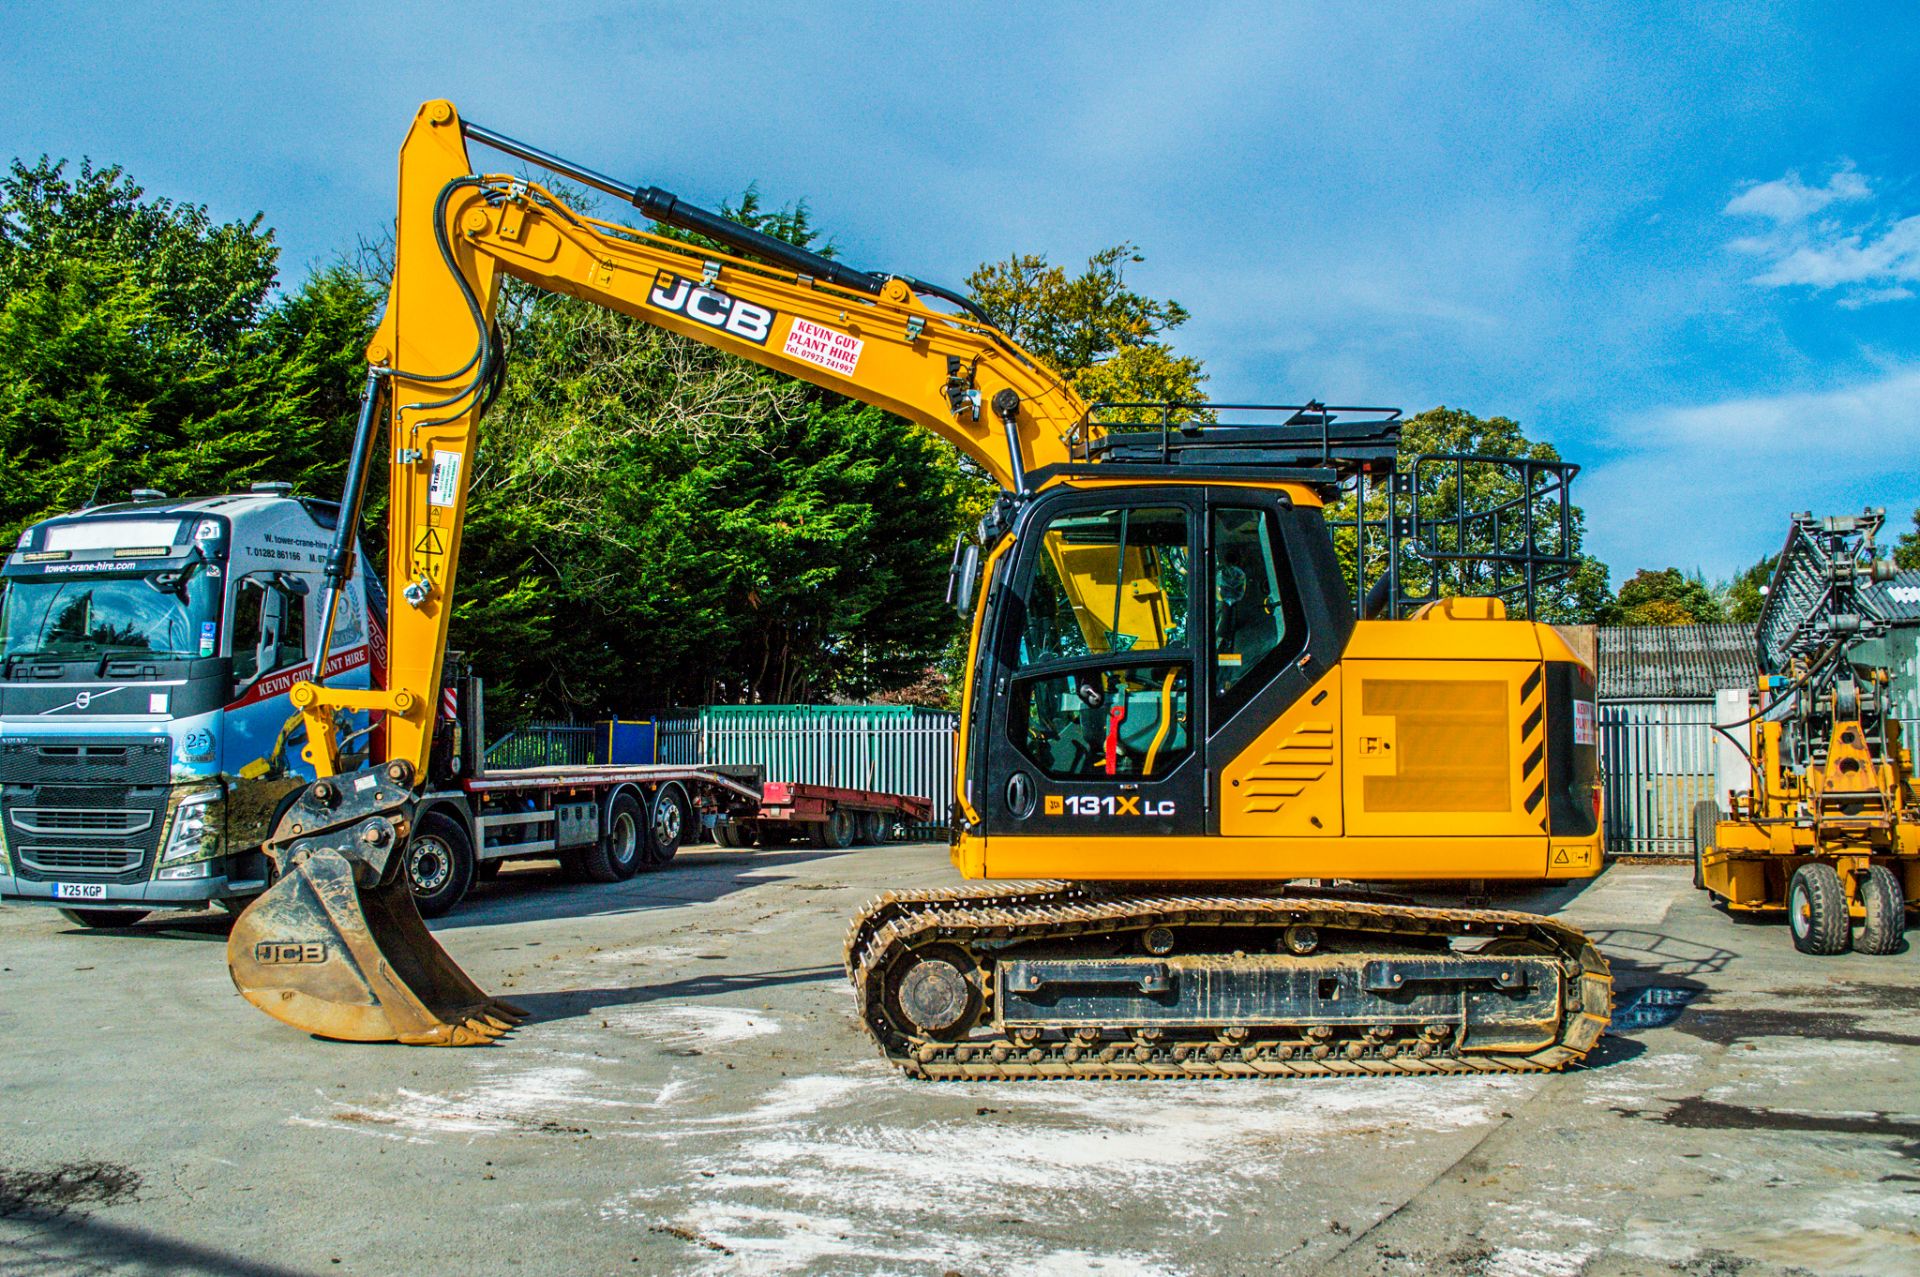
[973,488,1206,835]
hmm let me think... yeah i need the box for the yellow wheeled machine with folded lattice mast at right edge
[1693,509,1920,954]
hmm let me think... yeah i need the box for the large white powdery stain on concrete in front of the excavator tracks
[607,1066,1540,1273]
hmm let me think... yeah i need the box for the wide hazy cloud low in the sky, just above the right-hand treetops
[1578,365,1920,582]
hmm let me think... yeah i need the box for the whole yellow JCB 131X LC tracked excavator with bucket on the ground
[228,102,1611,1077]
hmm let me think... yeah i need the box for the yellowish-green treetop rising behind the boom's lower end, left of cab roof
[966,244,1206,403]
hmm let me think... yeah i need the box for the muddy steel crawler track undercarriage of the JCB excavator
[847,881,1613,1079]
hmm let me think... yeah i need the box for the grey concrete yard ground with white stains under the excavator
[0,847,1920,1277]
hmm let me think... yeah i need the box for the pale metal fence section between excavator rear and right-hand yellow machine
[1599,701,1715,856]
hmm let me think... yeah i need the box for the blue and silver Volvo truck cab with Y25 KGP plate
[0,484,386,926]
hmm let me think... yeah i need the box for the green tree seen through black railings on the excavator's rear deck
[1327,407,1607,624]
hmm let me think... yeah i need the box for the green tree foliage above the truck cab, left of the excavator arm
[0,159,374,540]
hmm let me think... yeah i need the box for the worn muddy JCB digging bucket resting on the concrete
[227,768,526,1047]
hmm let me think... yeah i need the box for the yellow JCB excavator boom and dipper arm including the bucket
[228,102,1087,1045]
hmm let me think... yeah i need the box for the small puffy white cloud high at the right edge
[1720,167,1920,309]
